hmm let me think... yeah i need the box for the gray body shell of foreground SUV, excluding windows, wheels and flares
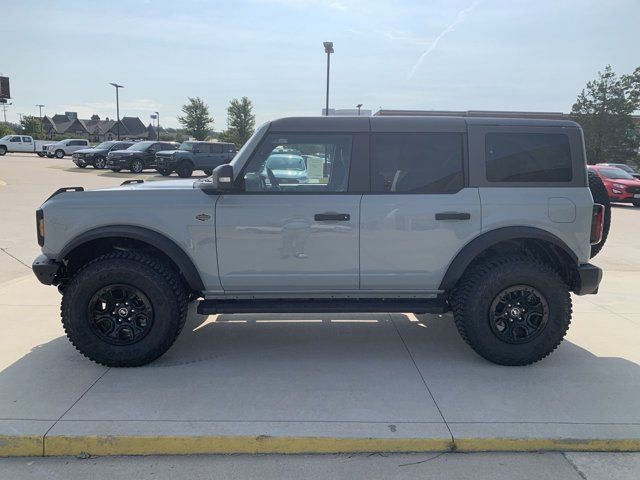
[36,117,593,298]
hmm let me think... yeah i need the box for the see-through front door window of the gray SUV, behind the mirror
[243,133,351,193]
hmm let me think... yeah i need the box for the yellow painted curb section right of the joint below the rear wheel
[454,438,640,452]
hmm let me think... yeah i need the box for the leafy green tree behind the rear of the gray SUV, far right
[571,65,639,164]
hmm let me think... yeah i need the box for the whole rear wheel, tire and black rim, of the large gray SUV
[451,256,571,365]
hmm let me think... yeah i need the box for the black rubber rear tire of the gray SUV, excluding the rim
[449,255,571,365]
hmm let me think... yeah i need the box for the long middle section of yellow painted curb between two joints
[44,435,452,456]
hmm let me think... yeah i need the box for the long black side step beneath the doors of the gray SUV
[198,298,449,315]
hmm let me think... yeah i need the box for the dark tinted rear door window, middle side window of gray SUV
[371,133,463,193]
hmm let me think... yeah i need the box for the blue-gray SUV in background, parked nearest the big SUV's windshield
[156,142,236,178]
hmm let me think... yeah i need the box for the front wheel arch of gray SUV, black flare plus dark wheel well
[56,225,205,292]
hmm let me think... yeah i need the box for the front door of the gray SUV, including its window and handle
[216,134,361,292]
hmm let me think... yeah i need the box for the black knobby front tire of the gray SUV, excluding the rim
[60,251,188,367]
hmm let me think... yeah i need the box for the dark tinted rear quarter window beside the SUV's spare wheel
[485,133,572,182]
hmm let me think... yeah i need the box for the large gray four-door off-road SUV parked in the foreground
[33,117,603,366]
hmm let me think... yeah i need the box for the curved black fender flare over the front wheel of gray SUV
[56,225,205,292]
